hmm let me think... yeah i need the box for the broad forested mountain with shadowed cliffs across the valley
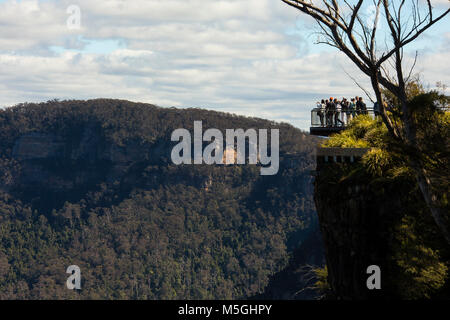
[0,99,321,299]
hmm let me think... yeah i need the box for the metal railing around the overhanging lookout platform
[311,108,375,128]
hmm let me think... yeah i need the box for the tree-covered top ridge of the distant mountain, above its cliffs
[0,99,313,153]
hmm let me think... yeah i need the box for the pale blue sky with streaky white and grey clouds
[0,0,450,130]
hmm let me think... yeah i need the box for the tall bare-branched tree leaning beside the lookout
[282,0,450,244]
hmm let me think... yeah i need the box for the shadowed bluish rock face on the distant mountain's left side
[5,123,171,210]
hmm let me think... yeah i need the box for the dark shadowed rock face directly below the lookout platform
[314,164,401,300]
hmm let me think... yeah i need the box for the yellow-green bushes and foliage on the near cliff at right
[323,92,450,299]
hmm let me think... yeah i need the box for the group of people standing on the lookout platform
[316,96,367,127]
